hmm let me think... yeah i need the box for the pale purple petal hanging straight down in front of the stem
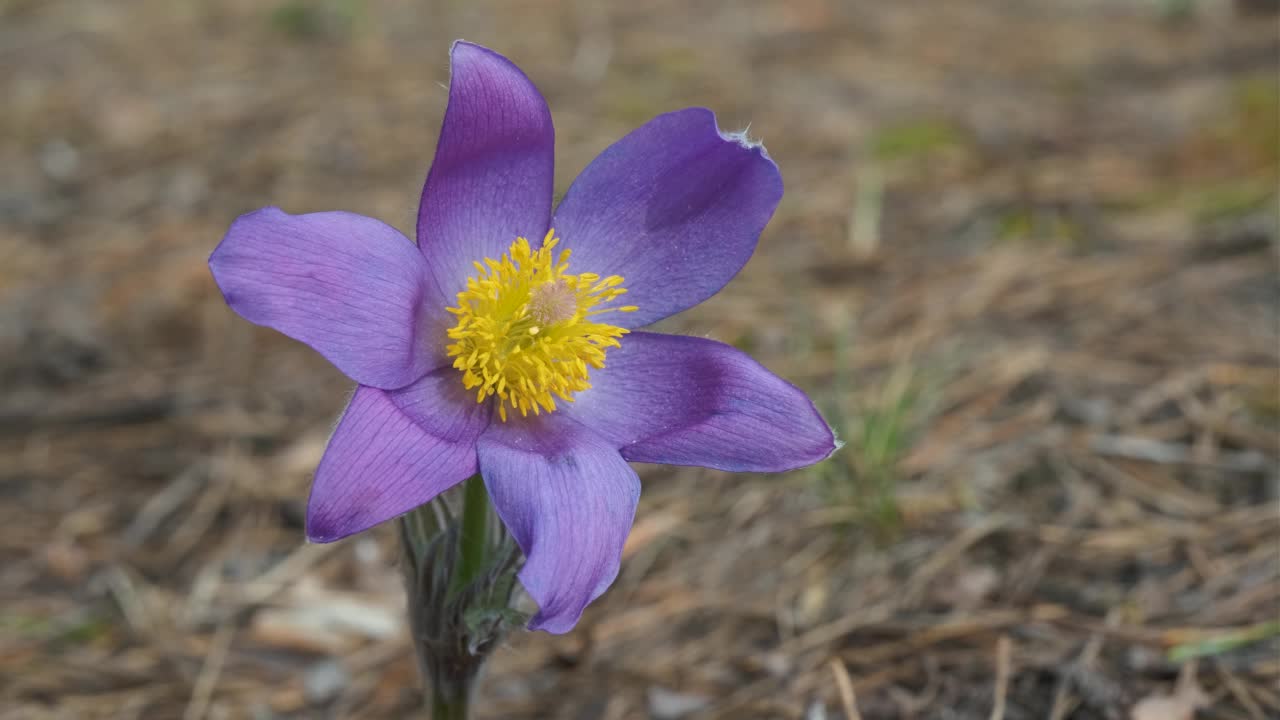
[477,414,640,633]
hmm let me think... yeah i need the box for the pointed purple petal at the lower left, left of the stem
[307,386,476,542]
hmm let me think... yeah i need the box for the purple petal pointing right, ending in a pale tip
[564,332,837,473]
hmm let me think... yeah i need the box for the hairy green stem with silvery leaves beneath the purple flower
[399,475,521,720]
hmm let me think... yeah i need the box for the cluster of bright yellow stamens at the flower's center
[448,231,637,421]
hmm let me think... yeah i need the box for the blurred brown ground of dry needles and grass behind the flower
[0,0,1280,720]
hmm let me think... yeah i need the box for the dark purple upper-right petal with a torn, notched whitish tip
[552,108,782,328]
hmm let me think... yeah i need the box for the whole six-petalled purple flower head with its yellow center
[209,42,836,633]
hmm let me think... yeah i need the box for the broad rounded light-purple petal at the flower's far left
[209,208,448,388]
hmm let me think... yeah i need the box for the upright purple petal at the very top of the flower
[417,41,556,298]
